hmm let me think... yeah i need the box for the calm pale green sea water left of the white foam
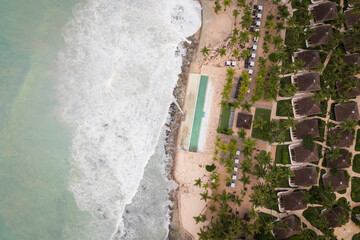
[0,0,87,240]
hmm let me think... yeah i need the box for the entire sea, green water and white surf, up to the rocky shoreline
[0,0,201,240]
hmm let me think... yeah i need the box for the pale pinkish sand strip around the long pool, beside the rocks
[173,0,248,239]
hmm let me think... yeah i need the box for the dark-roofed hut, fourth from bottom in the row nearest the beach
[289,144,319,165]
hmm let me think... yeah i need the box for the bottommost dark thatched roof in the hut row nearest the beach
[273,215,301,239]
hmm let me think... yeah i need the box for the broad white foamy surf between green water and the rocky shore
[59,0,201,239]
